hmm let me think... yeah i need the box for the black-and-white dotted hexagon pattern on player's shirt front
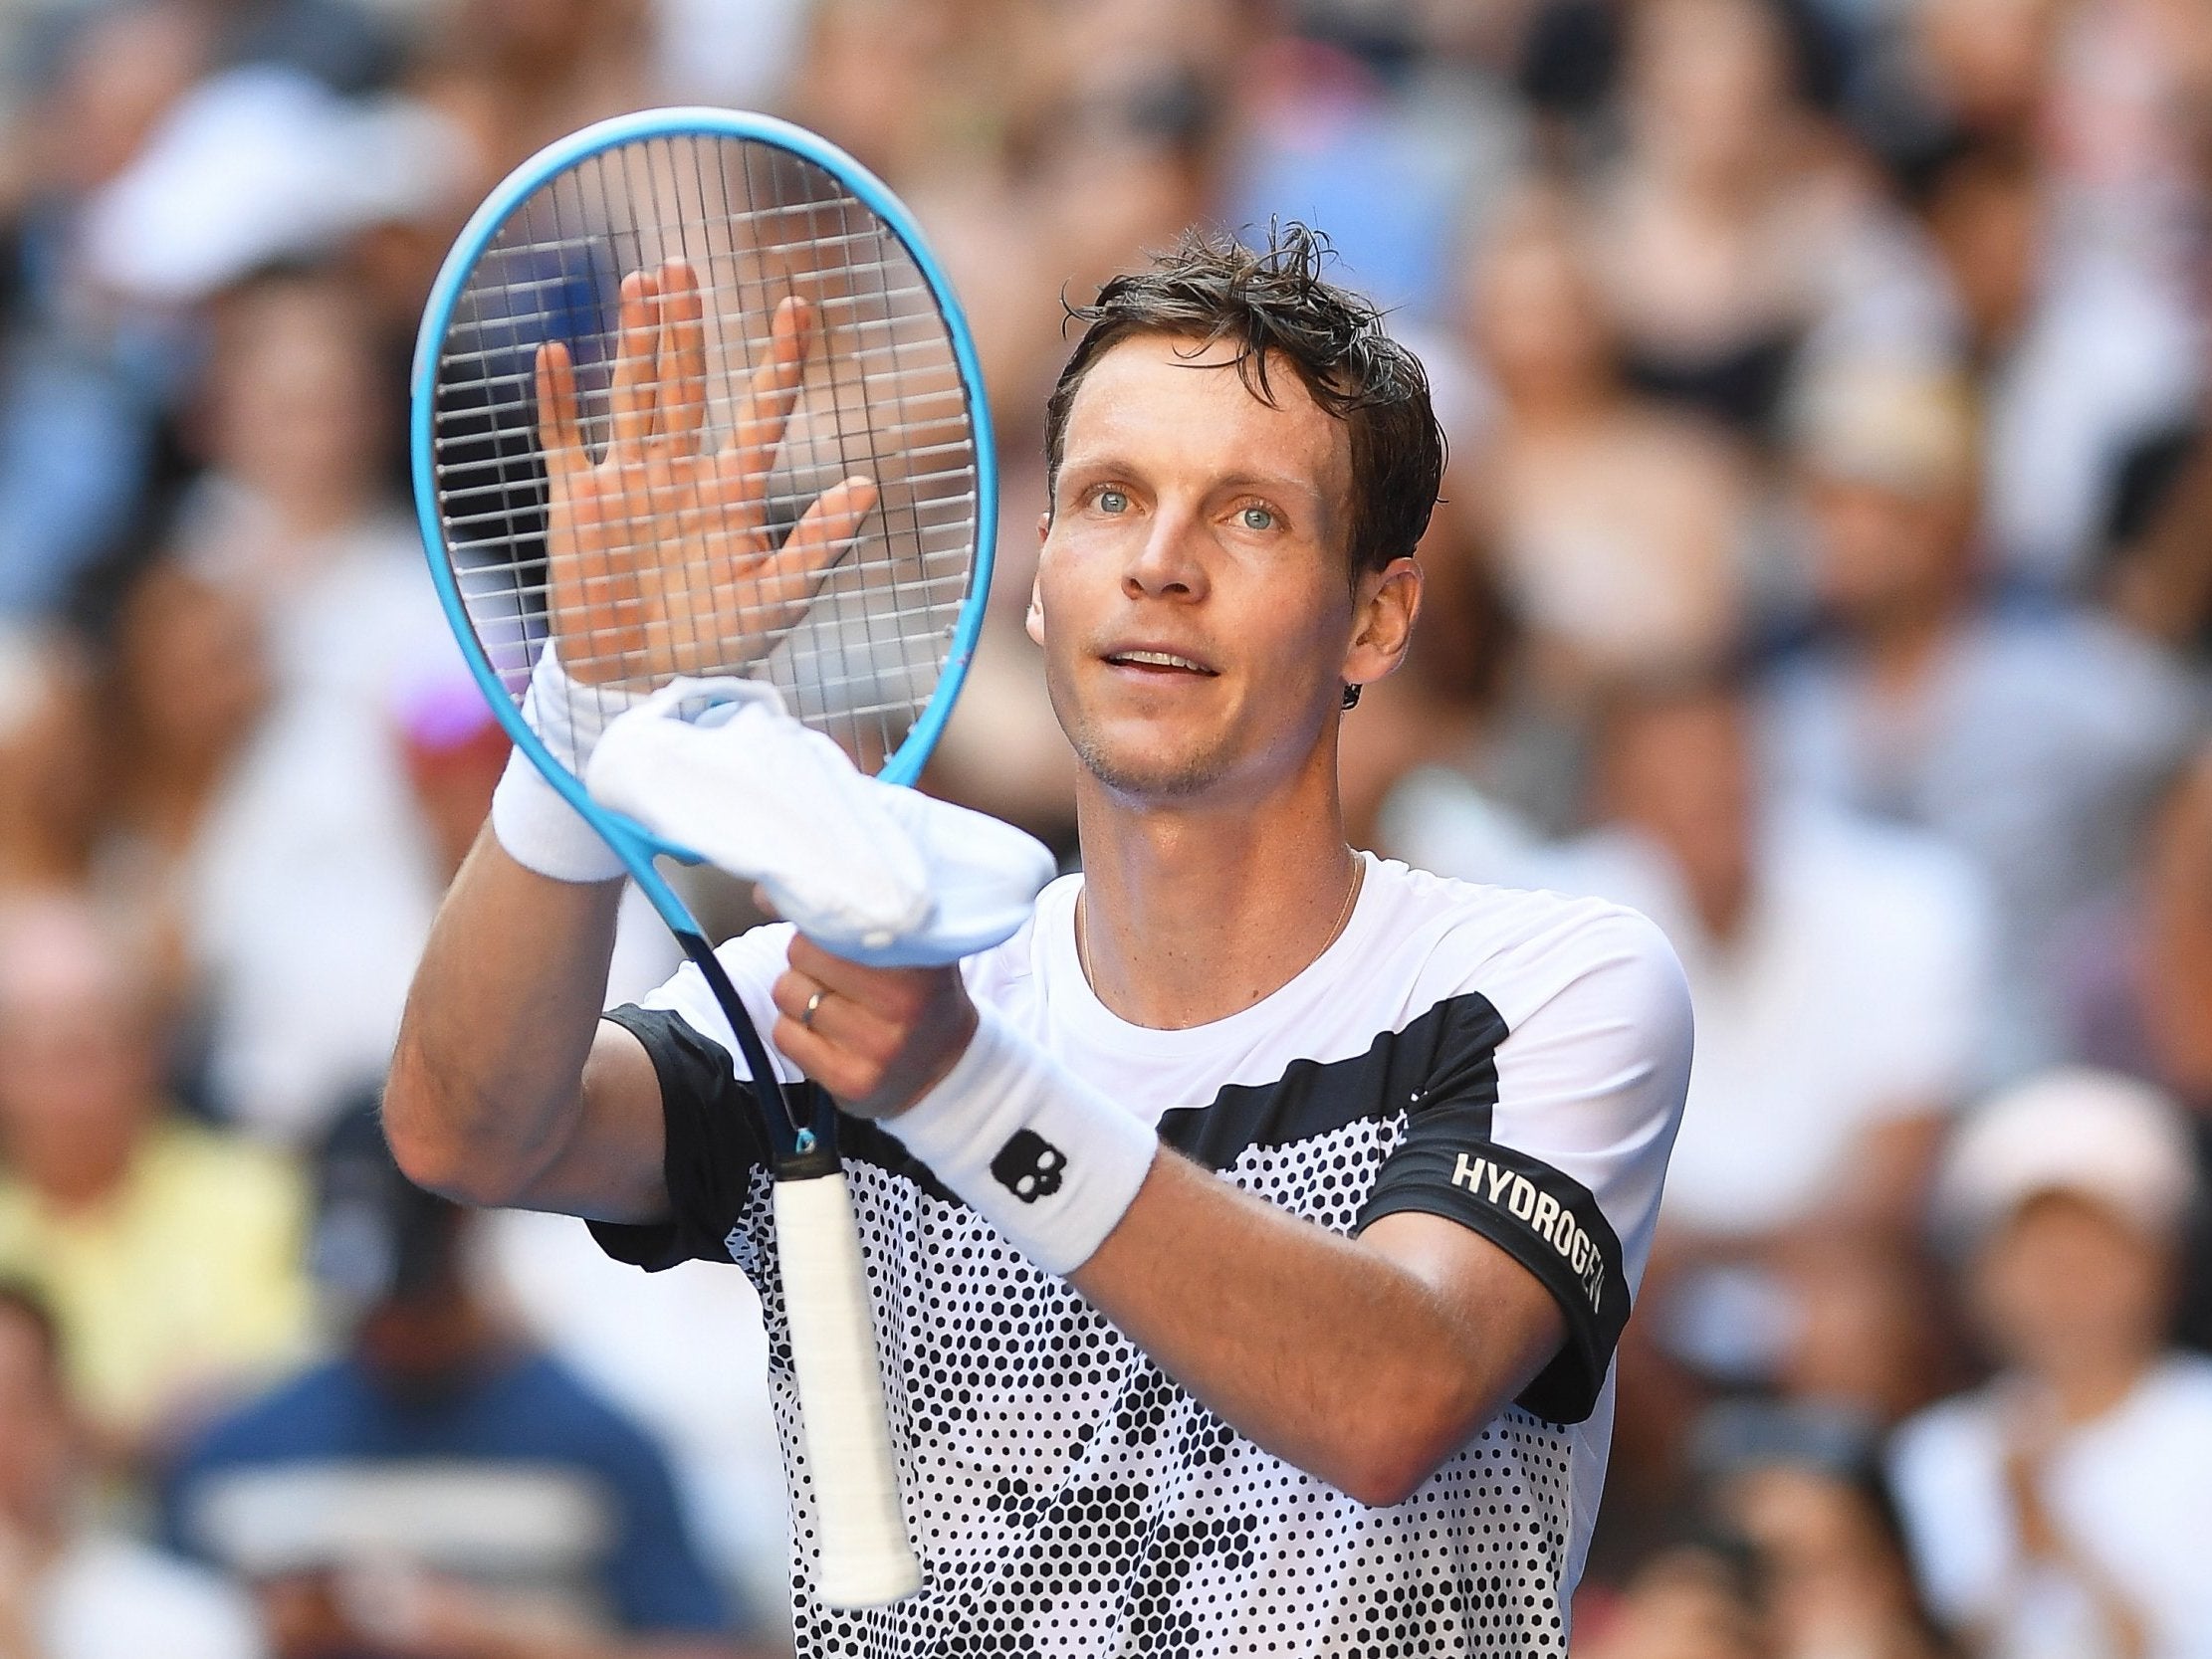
[730,1120,1571,1659]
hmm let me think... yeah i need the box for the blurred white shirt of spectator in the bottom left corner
[38,1536,268,1659]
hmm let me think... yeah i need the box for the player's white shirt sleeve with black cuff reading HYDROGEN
[1358,905,1690,1422]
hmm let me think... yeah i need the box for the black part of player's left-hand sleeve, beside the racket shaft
[588,1002,768,1272]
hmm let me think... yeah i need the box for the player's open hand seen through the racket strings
[538,259,876,684]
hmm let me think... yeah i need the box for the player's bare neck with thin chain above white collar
[1077,752,1363,1031]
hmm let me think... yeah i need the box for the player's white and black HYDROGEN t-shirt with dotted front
[595,861,1690,1659]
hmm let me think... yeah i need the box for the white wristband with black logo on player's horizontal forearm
[883,1009,1159,1276]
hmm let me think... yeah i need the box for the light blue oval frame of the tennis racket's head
[407,106,997,937]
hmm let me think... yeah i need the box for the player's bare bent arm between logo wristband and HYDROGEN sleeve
[1073,1152,1564,1504]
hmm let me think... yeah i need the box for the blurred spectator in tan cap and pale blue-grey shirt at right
[1767,363,2196,1071]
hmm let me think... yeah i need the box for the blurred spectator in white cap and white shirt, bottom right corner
[1893,1071,2212,1659]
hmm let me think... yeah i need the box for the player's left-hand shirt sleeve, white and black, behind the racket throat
[586,927,798,1272]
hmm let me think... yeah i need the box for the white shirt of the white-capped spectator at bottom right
[1891,1353,2212,1659]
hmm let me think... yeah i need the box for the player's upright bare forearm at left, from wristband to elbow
[385,830,621,1203]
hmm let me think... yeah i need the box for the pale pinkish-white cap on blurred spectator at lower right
[1935,1066,2196,1243]
